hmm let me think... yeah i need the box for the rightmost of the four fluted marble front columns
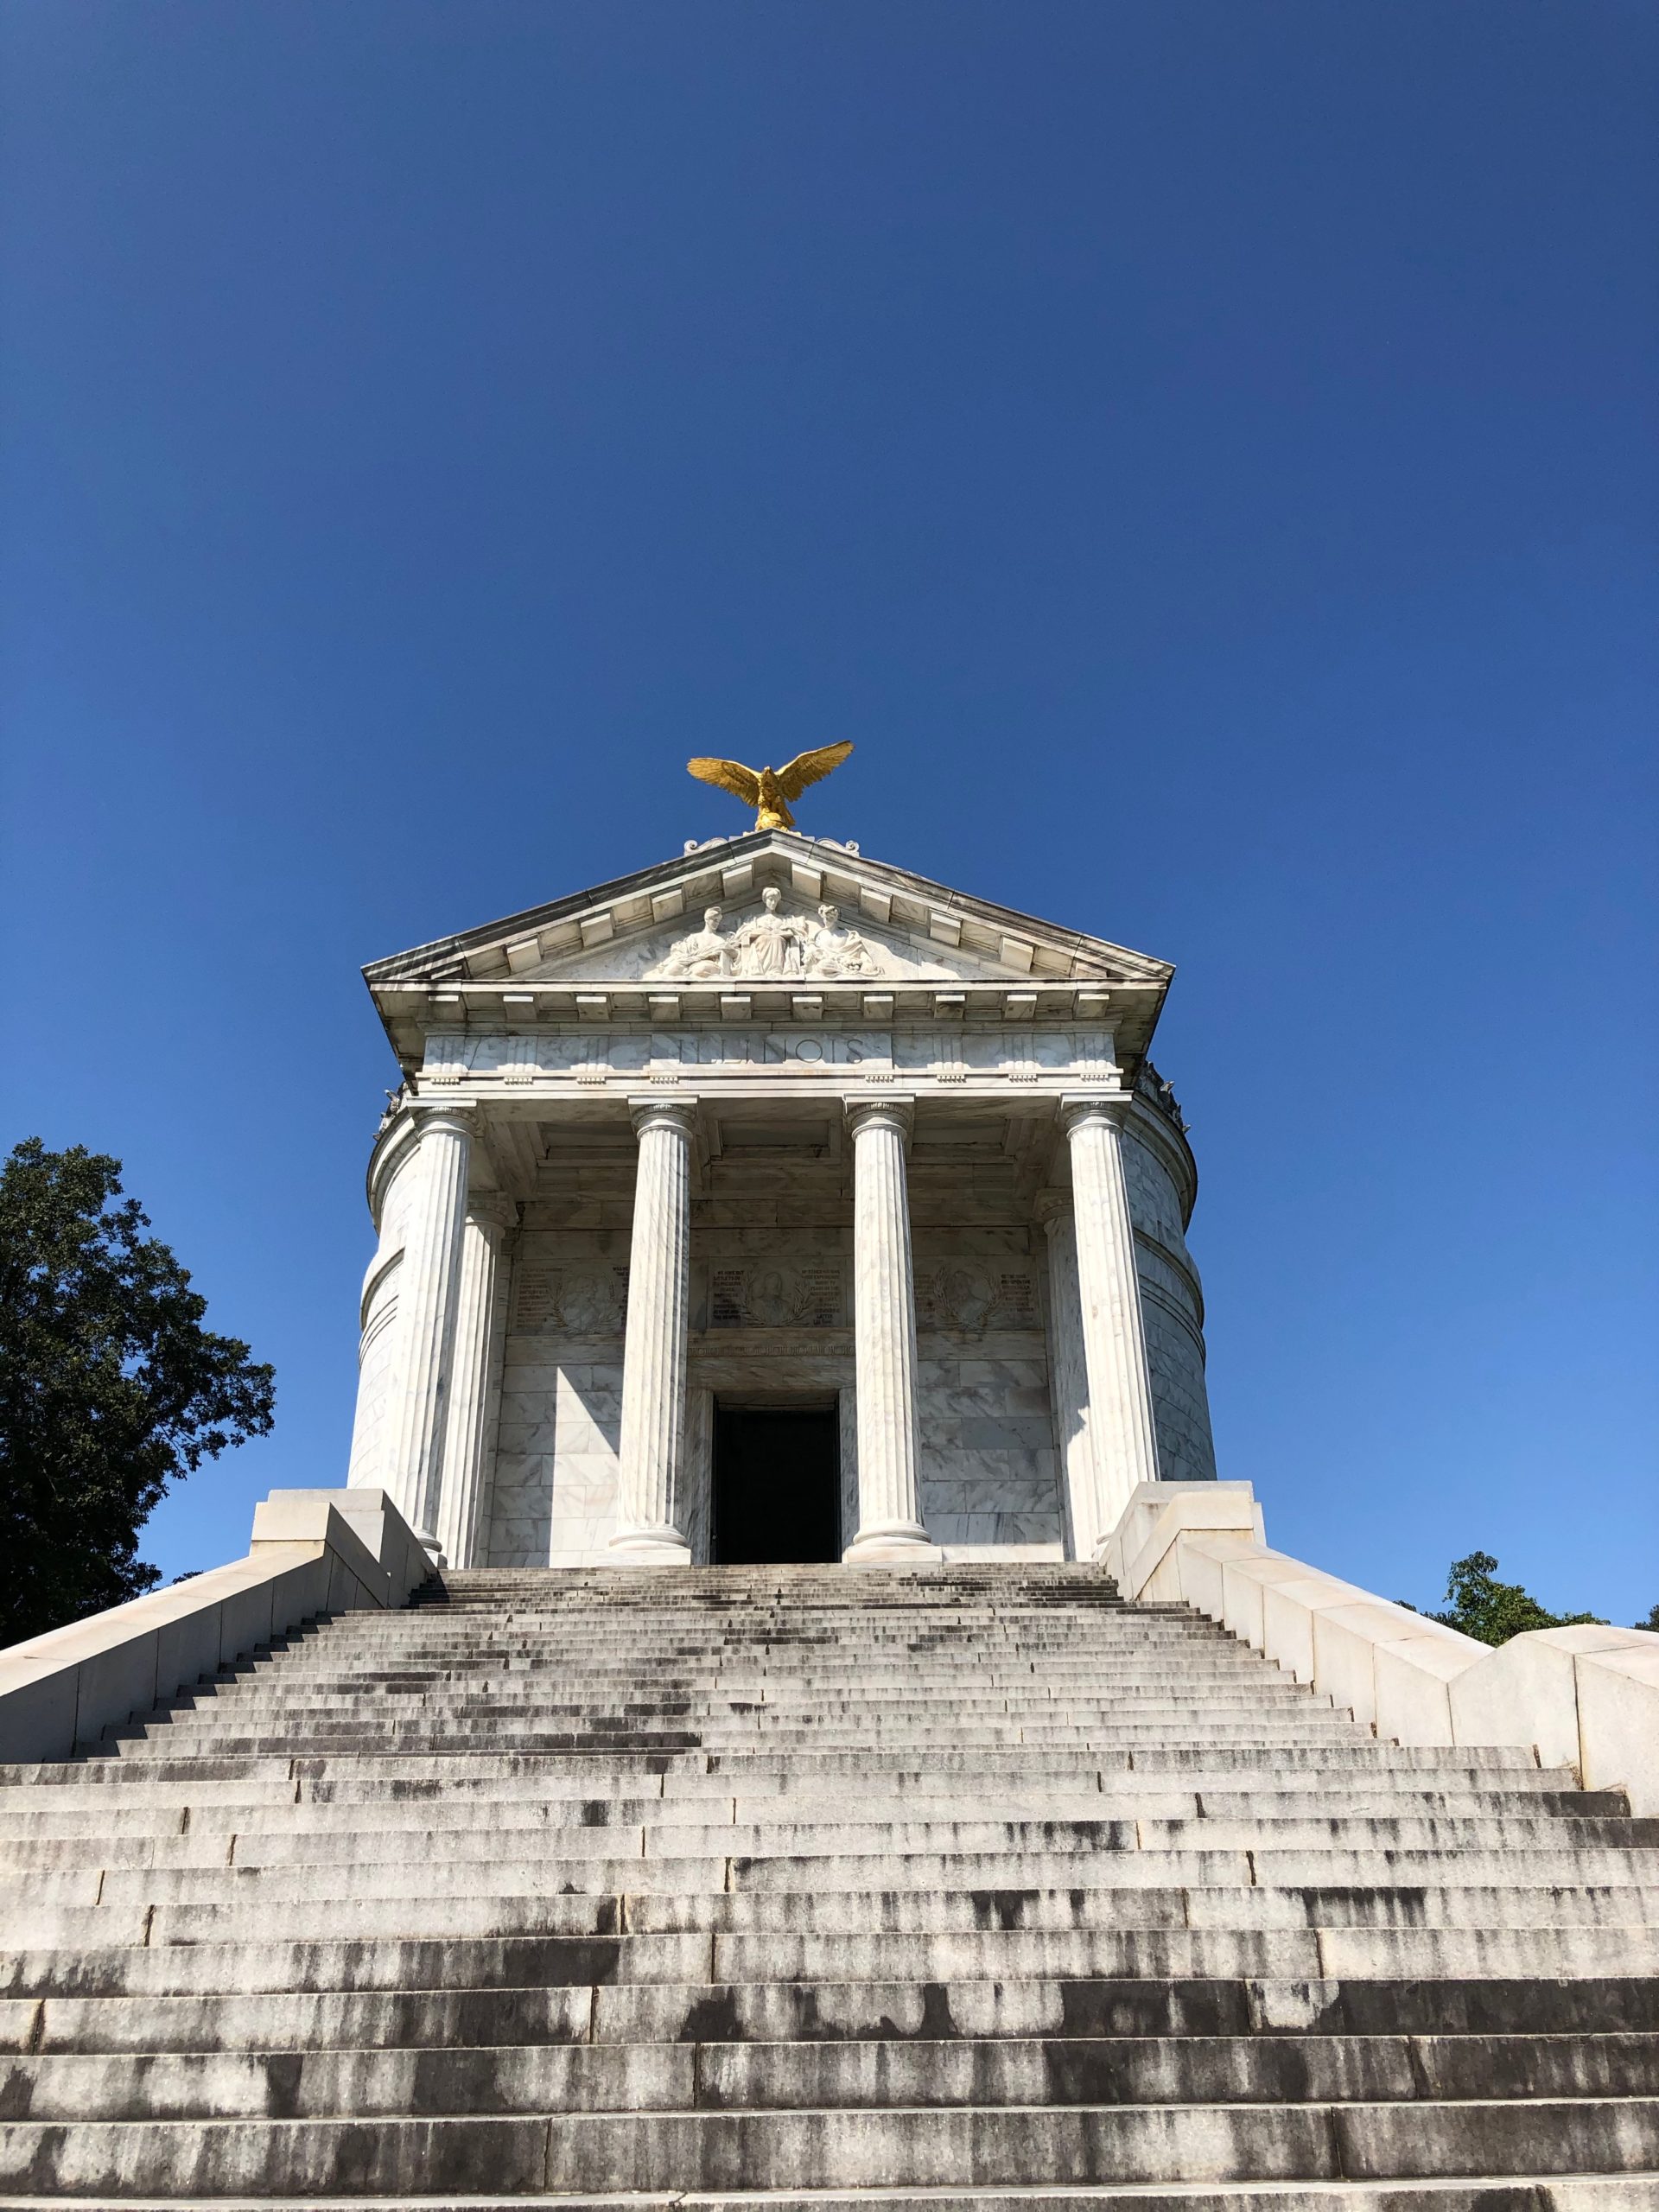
[1059,1097,1157,1535]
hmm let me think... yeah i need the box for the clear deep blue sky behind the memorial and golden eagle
[0,0,1659,1621]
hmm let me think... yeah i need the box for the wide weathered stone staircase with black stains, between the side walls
[0,1566,1659,2212]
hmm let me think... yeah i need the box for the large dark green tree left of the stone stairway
[0,1137,276,1643]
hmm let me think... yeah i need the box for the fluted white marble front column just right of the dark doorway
[842,1097,929,1566]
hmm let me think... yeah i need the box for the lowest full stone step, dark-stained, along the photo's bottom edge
[0,2097,1659,2196]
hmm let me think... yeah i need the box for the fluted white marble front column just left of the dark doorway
[611,1099,696,1566]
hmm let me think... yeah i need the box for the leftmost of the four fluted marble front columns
[387,1106,474,1553]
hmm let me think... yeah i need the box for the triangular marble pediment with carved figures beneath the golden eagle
[365,830,1173,995]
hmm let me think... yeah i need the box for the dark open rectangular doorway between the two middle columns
[710,1400,841,1566]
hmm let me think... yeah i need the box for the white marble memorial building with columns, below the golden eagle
[349,830,1214,1568]
